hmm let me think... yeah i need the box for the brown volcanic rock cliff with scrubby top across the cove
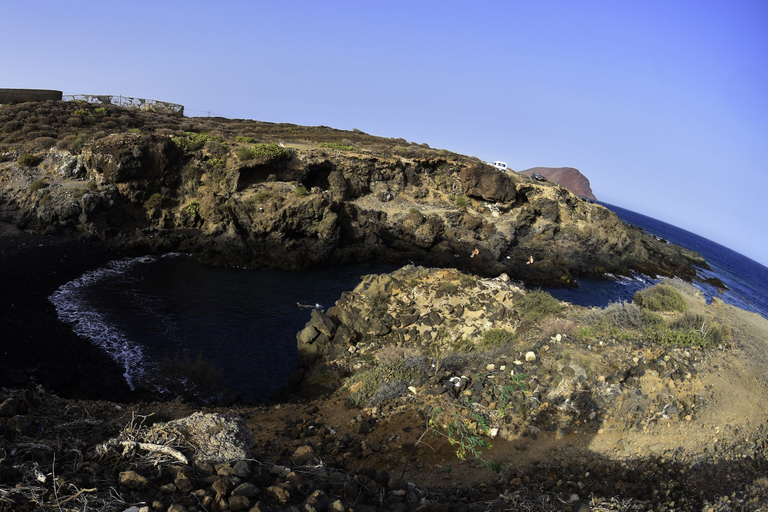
[0,102,706,285]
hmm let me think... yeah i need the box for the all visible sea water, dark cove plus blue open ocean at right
[50,205,768,403]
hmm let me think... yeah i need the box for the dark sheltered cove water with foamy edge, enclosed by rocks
[51,255,396,402]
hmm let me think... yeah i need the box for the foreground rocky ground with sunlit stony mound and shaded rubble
[0,267,768,512]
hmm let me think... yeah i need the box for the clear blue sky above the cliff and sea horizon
[0,0,768,265]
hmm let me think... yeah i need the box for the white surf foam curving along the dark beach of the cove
[48,256,155,389]
